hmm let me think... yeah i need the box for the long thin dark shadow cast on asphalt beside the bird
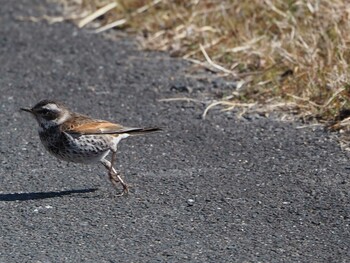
[0,188,98,202]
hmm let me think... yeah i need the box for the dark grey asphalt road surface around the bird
[0,0,350,262]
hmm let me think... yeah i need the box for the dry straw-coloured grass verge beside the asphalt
[61,0,350,127]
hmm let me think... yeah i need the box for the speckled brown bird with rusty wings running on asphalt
[21,99,161,195]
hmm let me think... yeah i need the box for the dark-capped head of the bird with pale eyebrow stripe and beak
[21,100,70,129]
